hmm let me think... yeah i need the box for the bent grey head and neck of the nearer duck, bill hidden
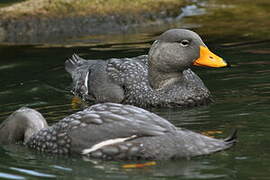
[0,108,48,144]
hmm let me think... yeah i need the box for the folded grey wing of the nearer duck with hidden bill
[67,103,176,153]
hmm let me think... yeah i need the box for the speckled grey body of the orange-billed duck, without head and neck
[66,55,211,107]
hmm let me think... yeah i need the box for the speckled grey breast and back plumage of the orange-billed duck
[107,55,210,107]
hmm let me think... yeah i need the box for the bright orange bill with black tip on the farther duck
[193,46,228,68]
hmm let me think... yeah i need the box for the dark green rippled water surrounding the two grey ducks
[0,0,270,180]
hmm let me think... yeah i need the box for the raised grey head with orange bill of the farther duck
[149,29,228,88]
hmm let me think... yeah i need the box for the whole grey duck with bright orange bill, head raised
[65,29,228,107]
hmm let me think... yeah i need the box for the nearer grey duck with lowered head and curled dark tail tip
[0,103,236,160]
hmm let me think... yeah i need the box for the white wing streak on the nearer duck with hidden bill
[82,135,137,154]
